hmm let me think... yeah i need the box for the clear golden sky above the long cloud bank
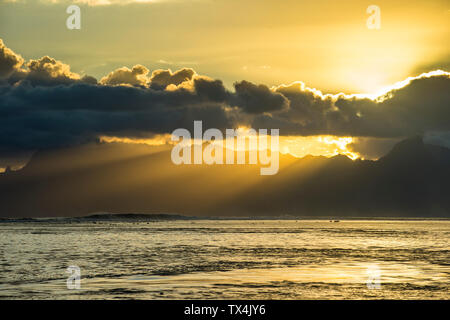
[0,0,450,93]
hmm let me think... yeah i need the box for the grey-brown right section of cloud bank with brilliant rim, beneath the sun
[264,72,450,138]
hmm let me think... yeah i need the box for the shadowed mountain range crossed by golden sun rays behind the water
[0,137,450,217]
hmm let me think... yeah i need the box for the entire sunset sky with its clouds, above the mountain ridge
[0,0,450,167]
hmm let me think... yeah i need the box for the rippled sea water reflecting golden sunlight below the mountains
[0,220,450,299]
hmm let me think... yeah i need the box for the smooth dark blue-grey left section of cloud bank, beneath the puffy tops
[0,82,233,155]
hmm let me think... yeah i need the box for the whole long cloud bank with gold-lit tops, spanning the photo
[0,38,450,158]
